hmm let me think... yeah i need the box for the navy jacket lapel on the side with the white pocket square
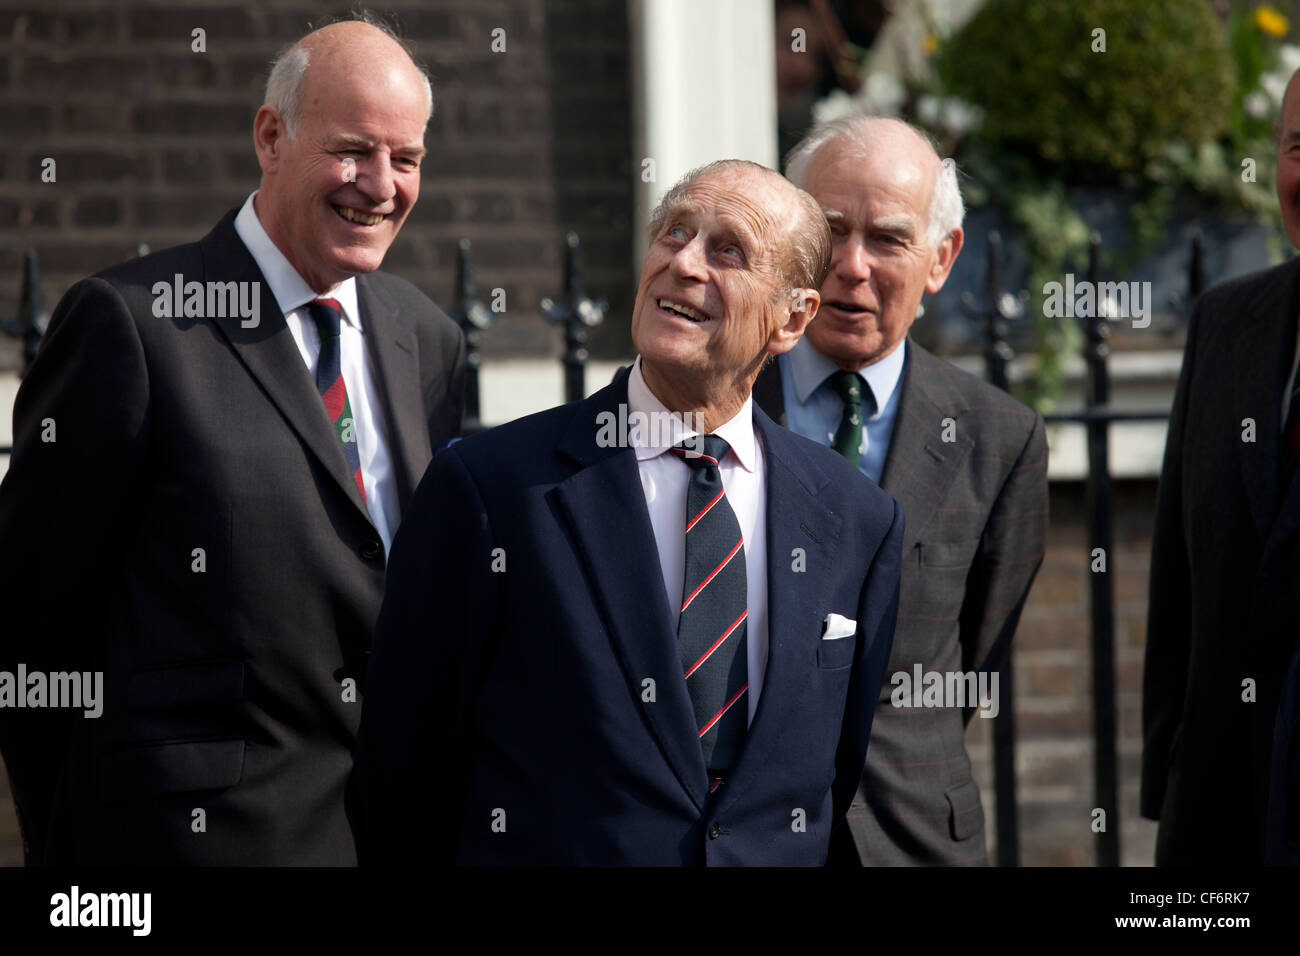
[720,408,855,809]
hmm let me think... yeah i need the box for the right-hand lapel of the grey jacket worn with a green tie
[880,339,975,553]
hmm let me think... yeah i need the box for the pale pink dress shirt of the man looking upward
[628,358,767,721]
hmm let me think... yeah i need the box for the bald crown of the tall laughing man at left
[265,20,433,138]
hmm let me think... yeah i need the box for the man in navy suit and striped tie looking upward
[358,160,902,865]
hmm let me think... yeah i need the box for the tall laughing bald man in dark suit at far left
[0,14,464,865]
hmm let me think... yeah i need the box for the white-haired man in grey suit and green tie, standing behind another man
[754,116,1048,865]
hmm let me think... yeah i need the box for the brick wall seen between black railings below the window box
[966,480,1156,866]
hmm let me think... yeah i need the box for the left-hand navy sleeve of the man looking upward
[352,446,498,866]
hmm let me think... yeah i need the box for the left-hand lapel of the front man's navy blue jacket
[555,372,709,808]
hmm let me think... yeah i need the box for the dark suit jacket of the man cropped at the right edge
[1141,259,1300,865]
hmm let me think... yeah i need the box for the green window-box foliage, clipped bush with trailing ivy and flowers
[913,0,1300,411]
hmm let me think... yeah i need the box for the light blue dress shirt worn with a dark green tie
[776,338,907,485]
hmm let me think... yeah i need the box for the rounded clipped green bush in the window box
[939,0,1232,185]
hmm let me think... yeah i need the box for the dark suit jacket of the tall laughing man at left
[0,212,465,865]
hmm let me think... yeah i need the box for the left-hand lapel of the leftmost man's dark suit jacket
[200,212,369,520]
